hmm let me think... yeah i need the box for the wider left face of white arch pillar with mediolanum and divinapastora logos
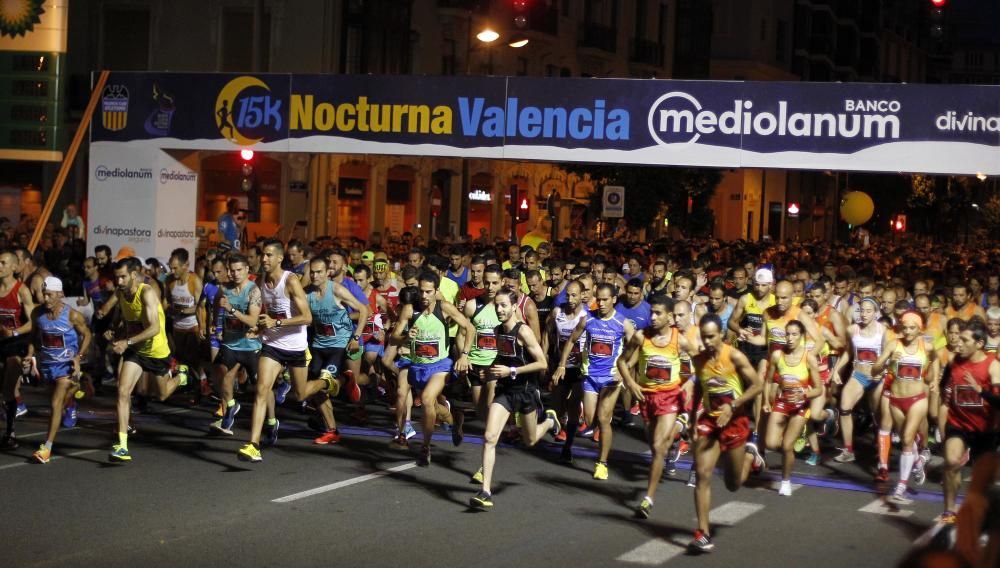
[87,144,159,258]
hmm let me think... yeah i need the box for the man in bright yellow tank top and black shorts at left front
[105,257,181,462]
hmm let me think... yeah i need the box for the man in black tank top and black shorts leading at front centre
[469,288,559,509]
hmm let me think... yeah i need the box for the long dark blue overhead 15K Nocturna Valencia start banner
[91,73,1000,175]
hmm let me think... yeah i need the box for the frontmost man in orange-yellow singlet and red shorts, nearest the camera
[689,312,764,552]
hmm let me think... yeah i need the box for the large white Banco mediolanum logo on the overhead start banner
[649,91,900,147]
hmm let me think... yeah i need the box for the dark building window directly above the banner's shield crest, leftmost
[101,8,150,71]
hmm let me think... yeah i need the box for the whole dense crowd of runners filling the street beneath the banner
[0,232,1000,552]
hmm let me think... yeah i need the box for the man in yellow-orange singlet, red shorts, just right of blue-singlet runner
[617,294,693,518]
